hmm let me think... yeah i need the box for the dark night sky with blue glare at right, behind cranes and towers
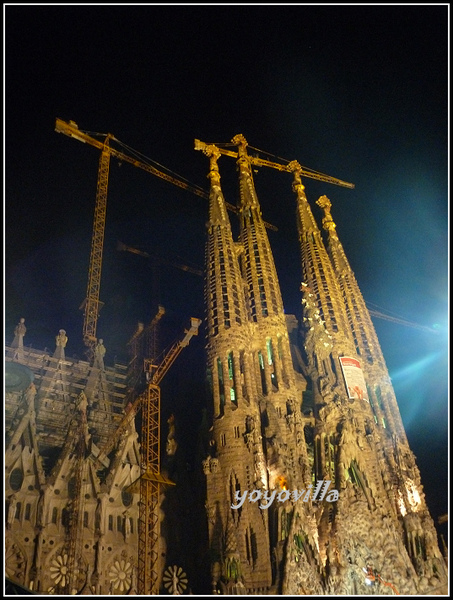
[4,4,449,536]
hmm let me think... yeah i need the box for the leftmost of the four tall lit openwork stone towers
[203,139,270,588]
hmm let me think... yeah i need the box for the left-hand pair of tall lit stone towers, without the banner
[203,136,315,593]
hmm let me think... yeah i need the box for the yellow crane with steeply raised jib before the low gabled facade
[91,317,201,595]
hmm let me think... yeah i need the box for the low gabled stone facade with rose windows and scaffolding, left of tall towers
[5,332,140,595]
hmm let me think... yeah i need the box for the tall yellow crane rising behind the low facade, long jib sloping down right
[55,118,277,360]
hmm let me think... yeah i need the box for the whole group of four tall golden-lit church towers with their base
[197,135,446,595]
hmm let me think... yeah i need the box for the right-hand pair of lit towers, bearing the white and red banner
[292,163,446,594]
